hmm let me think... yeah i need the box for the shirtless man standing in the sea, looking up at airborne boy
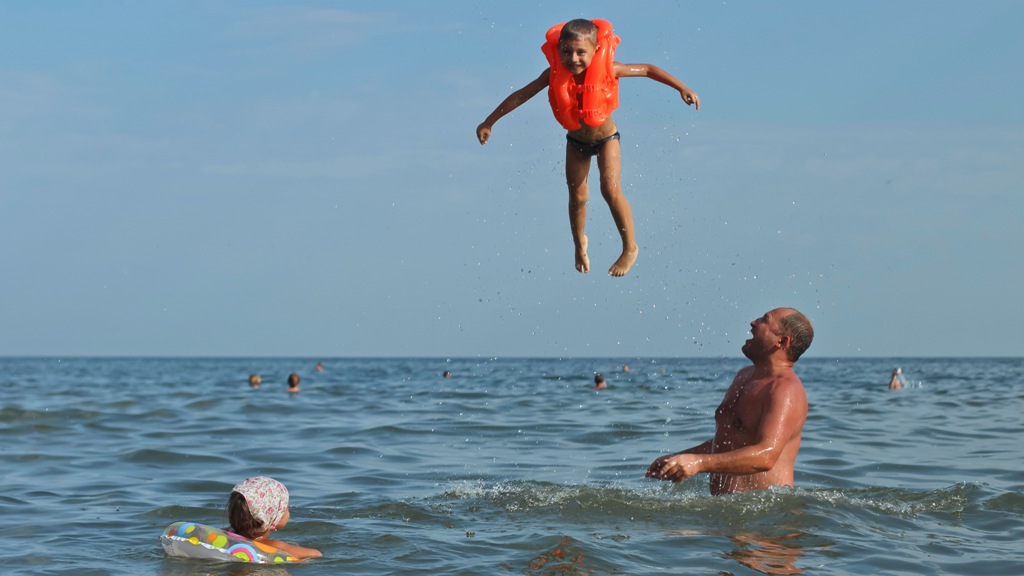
[647,308,814,495]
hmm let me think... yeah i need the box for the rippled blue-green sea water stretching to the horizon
[0,356,1024,576]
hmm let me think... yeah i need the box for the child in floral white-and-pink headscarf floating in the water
[227,476,323,559]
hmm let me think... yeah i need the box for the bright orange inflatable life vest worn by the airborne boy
[541,19,620,130]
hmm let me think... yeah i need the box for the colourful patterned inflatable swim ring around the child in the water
[160,522,301,564]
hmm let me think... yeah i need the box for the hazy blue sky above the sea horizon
[0,0,1024,359]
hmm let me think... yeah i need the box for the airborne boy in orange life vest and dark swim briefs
[476,19,700,276]
